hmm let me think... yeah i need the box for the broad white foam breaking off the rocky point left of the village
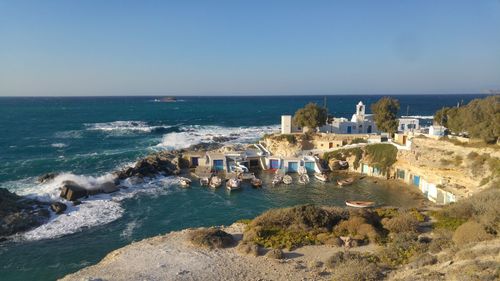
[157,125,279,149]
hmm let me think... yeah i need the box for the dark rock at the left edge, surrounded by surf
[0,188,49,238]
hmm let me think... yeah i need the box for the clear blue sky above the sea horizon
[0,0,500,96]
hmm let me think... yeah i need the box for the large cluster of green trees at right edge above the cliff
[434,95,500,143]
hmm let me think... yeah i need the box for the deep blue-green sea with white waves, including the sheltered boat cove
[0,94,484,281]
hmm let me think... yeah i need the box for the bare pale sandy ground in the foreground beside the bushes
[61,224,375,281]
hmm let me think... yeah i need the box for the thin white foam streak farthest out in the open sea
[84,121,171,133]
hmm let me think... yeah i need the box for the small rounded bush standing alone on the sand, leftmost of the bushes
[189,228,235,249]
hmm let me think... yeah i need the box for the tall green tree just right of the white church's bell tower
[371,97,399,135]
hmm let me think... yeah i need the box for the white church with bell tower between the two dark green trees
[320,101,378,134]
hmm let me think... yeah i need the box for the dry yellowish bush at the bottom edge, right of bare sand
[326,252,382,281]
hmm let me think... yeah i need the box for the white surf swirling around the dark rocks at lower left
[5,173,179,240]
